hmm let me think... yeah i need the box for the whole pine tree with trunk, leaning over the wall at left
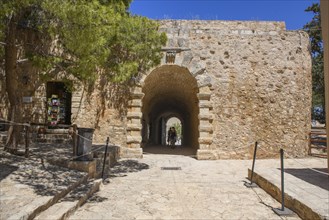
[0,0,166,154]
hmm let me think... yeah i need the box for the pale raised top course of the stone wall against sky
[156,19,286,31]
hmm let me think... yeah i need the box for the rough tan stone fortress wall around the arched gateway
[2,20,312,159]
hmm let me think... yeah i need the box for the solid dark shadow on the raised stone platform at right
[284,168,329,191]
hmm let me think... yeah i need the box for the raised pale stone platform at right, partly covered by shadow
[250,158,329,219]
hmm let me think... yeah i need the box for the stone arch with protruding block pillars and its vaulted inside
[125,64,213,159]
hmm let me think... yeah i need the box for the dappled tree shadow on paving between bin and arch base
[109,160,150,177]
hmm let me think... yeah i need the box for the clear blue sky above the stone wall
[130,0,319,30]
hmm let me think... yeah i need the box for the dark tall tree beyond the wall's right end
[303,3,325,120]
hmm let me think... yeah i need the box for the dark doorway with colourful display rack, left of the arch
[46,82,72,127]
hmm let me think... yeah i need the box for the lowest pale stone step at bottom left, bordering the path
[35,179,102,220]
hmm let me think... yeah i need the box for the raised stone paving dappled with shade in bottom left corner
[0,145,86,220]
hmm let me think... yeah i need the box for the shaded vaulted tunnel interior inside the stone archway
[142,65,199,149]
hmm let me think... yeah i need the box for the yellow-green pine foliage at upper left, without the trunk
[0,0,166,84]
